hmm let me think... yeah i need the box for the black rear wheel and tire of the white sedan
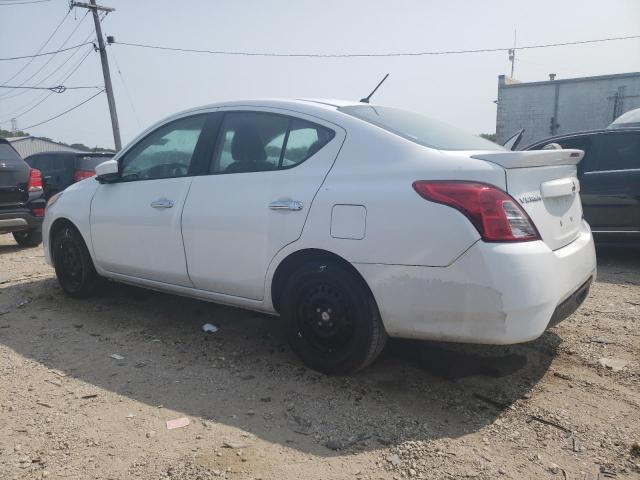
[280,260,387,375]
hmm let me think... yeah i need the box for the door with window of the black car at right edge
[580,131,640,232]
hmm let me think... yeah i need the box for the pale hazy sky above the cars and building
[0,0,640,147]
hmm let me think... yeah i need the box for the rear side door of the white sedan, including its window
[182,109,345,300]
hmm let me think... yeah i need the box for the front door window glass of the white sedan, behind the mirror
[120,115,207,181]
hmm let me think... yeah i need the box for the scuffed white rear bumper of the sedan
[355,223,596,344]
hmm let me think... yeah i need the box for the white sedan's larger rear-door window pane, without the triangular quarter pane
[210,112,289,173]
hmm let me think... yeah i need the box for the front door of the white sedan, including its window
[91,114,208,286]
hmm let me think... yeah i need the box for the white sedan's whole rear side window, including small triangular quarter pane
[210,112,335,173]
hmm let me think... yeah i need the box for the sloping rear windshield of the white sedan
[338,105,505,150]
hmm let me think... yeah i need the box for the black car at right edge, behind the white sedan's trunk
[524,127,640,242]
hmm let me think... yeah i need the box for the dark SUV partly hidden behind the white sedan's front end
[25,152,113,198]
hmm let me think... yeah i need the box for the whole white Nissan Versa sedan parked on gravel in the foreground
[43,100,596,374]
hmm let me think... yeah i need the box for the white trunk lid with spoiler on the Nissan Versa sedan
[472,150,583,250]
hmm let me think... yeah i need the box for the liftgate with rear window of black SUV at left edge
[0,141,29,207]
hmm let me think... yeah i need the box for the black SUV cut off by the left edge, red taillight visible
[0,138,45,247]
